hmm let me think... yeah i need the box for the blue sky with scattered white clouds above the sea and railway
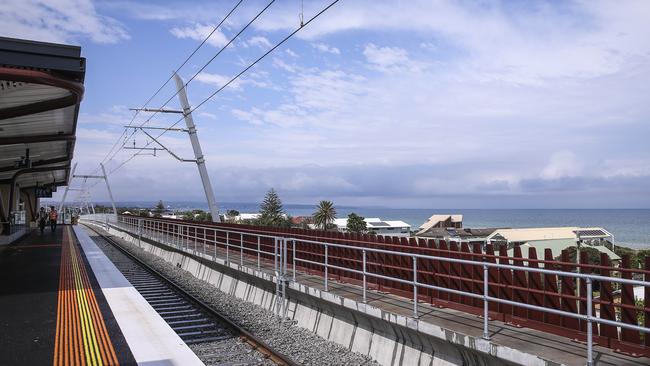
[0,0,650,208]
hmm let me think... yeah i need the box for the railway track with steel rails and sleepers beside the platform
[84,225,297,366]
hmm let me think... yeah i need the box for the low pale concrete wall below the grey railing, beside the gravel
[88,220,553,366]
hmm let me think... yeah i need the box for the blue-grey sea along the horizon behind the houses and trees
[101,202,650,249]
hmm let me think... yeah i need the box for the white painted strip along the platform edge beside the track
[73,225,203,366]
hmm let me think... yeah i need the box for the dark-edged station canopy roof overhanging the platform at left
[0,37,86,189]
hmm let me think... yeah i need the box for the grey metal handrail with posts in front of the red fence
[82,215,650,365]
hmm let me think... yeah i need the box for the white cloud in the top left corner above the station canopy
[0,0,129,43]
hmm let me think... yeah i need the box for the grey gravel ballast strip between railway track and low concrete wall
[89,229,379,366]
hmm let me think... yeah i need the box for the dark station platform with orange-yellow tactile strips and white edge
[0,225,202,365]
